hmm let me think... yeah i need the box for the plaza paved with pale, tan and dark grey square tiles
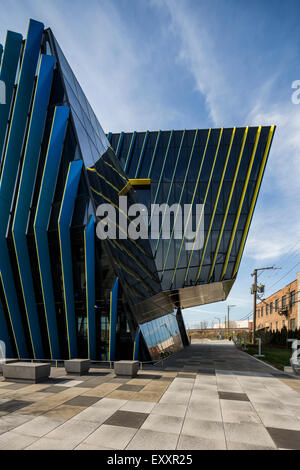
[0,342,300,450]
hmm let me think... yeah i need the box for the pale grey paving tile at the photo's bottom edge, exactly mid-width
[126,429,178,450]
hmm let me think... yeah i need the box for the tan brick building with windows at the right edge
[256,272,300,331]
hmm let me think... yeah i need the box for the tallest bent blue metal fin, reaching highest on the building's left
[0,20,44,357]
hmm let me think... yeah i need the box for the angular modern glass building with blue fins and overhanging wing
[0,20,275,360]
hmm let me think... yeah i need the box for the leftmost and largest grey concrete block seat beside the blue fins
[2,362,50,383]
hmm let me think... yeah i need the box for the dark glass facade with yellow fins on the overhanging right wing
[110,126,274,298]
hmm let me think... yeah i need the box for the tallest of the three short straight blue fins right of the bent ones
[84,217,96,359]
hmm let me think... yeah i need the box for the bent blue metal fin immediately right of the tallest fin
[13,56,55,359]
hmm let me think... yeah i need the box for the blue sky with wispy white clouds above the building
[0,0,300,325]
